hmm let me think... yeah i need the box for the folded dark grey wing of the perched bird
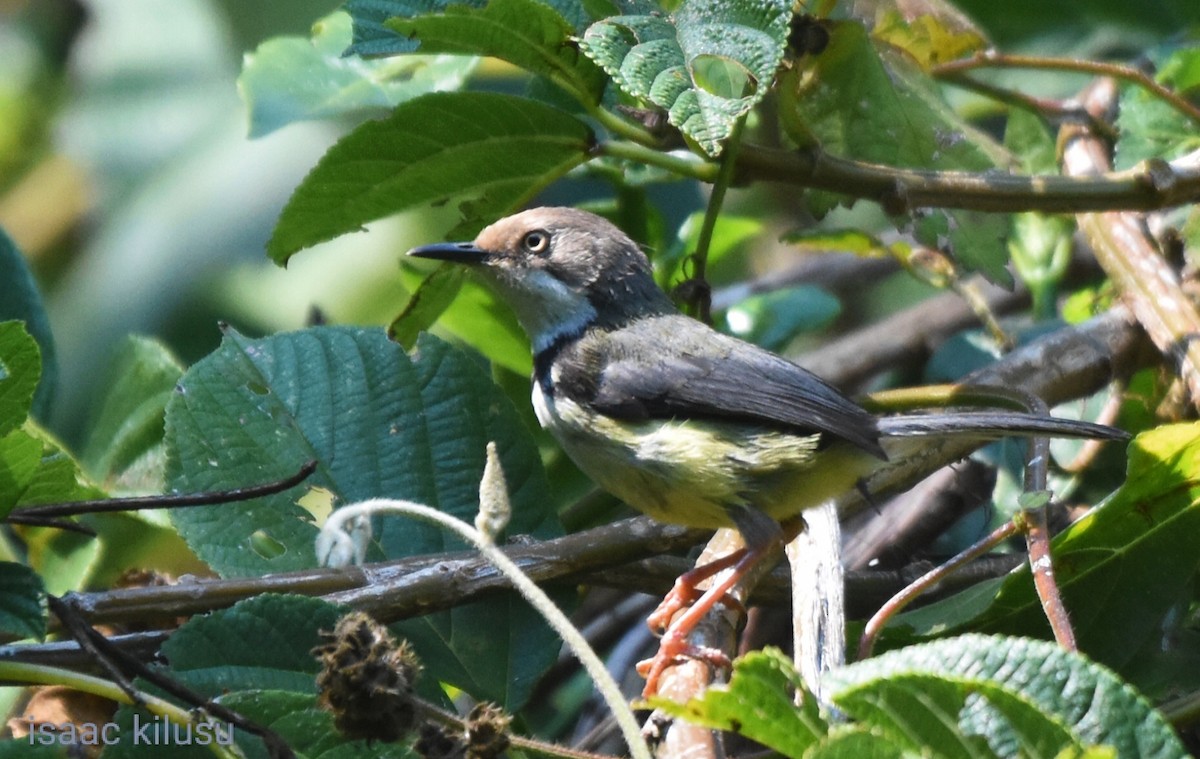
[558,315,884,458]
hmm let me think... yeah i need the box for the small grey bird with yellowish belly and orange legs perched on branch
[408,207,1126,695]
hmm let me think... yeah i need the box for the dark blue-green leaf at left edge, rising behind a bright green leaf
[0,229,59,420]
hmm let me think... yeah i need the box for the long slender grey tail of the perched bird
[878,411,1129,440]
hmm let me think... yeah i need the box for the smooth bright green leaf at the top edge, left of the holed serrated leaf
[386,0,604,102]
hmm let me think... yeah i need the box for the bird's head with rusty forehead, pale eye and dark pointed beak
[408,208,673,351]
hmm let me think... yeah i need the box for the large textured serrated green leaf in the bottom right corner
[829,635,1186,759]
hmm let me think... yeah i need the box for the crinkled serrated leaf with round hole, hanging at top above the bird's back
[581,0,792,156]
